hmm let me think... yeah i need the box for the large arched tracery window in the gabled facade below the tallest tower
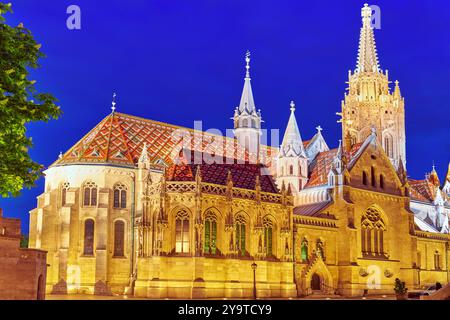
[361,207,386,256]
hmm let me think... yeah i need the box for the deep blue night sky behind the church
[0,0,450,232]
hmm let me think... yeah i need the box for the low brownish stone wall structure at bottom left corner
[0,209,47,300]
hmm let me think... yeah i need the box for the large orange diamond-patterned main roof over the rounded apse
[52,112,278,167]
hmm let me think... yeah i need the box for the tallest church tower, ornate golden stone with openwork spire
[338,4,406,168]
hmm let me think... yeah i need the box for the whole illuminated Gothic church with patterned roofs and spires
[29,5,450,299]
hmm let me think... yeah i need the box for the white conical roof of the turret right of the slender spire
[280,101,306,157]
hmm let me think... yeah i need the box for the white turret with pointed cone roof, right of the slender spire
[277,101,308,194]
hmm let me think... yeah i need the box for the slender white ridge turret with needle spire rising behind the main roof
[232,51,262,154]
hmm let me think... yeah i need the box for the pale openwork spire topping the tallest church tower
[355,3,380,73]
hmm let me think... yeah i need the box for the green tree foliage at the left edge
[0,2,61,197]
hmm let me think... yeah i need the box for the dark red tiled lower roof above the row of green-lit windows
[166,152,279,193]
